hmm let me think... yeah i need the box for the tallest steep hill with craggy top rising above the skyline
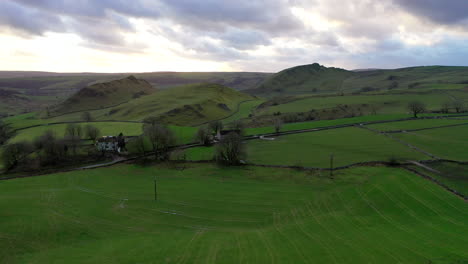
[247,63,354,96]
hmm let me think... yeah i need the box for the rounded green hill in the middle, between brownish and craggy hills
[99,83,254,125]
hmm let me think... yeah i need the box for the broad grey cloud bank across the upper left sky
[1,0,303,54]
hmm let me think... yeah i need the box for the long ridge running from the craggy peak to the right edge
[249,63,468,96]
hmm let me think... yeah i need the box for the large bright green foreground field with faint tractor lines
[0,164,468,264]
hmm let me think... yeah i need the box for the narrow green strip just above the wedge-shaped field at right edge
[369,119,468,131]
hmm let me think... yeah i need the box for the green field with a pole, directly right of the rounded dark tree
[247,127,429,168]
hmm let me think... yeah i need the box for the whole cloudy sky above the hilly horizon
[0,0,468,72]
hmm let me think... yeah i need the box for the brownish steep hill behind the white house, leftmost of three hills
[51,76,155,115]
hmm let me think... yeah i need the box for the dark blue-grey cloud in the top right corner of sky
[394,0,468,24]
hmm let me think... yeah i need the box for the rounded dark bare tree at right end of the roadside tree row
[215,133,245,165]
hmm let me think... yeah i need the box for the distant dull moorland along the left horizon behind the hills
[0,71,271,117]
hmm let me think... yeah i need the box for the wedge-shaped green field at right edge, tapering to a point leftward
[394,126,468,161]
